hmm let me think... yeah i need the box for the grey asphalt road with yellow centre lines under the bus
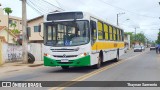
[0,50,160,90]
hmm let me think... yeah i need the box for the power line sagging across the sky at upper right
[98,0,159,18]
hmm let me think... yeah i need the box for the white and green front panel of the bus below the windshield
[44,43,92,66]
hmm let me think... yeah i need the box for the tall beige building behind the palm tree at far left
[0,8,22,31]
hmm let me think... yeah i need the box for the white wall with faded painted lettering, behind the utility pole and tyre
[2,43,44,63]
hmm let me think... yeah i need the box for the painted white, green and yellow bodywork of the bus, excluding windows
[44,12,125,67]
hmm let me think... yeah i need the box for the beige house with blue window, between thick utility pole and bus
[27,16,44,43]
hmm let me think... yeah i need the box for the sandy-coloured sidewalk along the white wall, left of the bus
[0,61,43,73]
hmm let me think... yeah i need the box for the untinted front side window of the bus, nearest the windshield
[90,20,97,44]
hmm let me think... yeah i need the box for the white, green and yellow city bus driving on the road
[44,12,124,69]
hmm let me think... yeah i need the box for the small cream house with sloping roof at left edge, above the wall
[0,26,17,44]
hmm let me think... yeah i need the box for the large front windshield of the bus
[44,20,90,47]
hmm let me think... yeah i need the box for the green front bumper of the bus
[44,55,90,67]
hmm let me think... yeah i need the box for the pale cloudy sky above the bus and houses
[0,0,160,40]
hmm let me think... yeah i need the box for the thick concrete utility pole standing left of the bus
[22,0,28,63]
